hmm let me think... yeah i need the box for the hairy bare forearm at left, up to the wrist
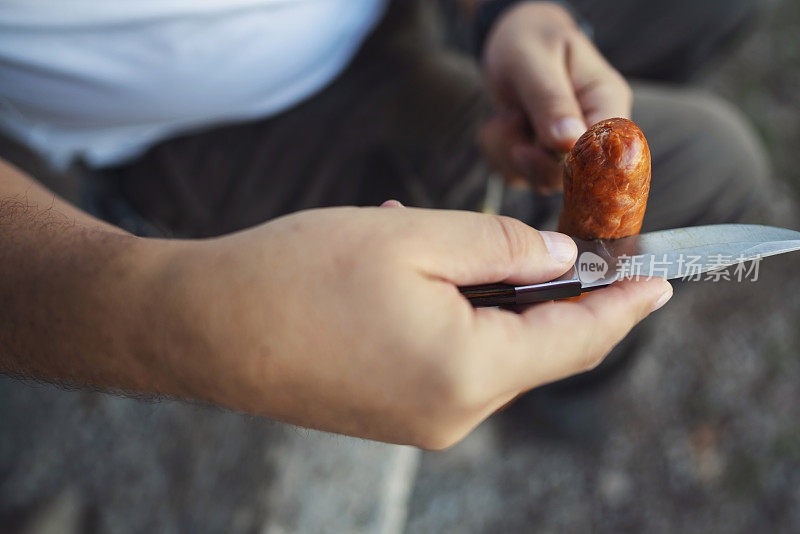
[0,162,186,393]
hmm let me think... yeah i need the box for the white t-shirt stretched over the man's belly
[0,0,387,167]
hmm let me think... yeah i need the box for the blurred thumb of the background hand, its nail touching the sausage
[514,45,586,152]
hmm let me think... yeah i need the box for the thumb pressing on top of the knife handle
[397,208,577,292]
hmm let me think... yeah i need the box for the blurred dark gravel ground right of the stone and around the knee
[407,0,800,534]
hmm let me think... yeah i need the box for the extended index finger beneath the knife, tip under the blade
[475,278,672,392]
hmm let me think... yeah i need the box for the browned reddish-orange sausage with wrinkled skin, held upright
[558,118,650,240]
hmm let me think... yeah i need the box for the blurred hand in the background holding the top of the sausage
[480,2,632,191]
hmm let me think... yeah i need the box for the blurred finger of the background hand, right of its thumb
[568,35,632,126]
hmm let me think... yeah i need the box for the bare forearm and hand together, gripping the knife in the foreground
[0,162,671,448]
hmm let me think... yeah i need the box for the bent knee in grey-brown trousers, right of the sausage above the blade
[634,87,769,230]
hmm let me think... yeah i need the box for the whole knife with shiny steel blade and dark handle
[459,224,800,307]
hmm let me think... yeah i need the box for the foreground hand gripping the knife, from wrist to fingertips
[164,204,671,449]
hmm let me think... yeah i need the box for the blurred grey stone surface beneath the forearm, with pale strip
[0,378,419,534]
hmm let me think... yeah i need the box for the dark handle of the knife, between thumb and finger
[458,269,583,308]
